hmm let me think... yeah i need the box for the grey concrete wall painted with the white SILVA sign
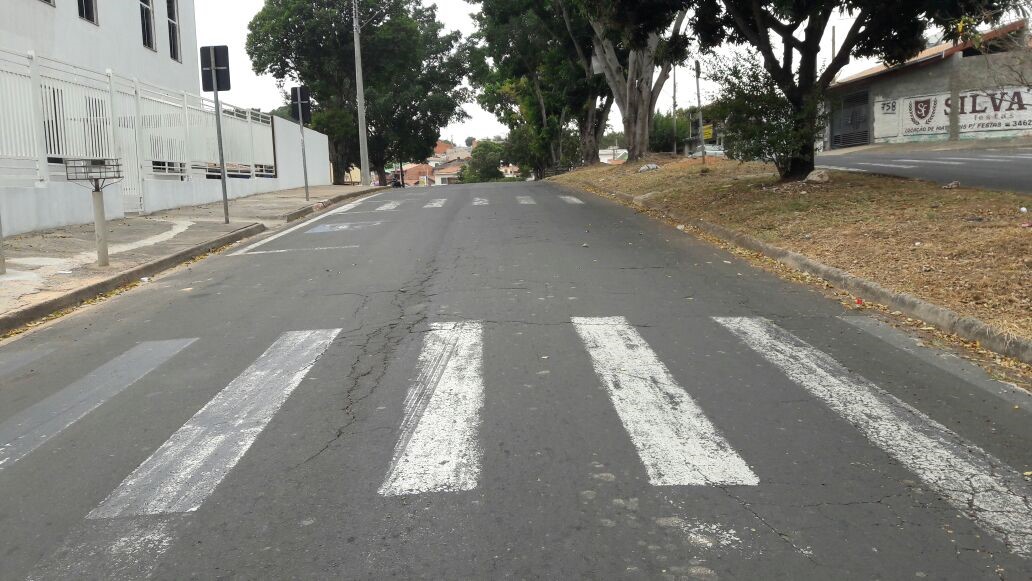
[833,52,1032,143]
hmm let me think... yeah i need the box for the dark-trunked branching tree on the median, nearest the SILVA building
[691,0,1013,179]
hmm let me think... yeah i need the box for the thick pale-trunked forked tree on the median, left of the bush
[580,0,687,160]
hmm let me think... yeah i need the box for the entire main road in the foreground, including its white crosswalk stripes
[0,183,1032,580]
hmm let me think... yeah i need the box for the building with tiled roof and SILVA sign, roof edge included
[825,22,1032,149]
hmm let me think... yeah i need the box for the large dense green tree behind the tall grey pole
[247,0,469,183]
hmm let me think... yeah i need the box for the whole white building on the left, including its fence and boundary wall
[0,0,332,235]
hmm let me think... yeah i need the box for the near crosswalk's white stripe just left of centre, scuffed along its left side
[380,321,484,496]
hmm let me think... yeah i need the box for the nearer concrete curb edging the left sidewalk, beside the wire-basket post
[0,223,265,335]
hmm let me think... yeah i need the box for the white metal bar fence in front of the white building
[0,49,276,212]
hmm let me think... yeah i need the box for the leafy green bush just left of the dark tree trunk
[710,54,825,176]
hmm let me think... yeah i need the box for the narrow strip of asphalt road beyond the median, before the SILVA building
[817,148,1032,194]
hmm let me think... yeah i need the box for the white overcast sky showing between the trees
[195,0,871,142]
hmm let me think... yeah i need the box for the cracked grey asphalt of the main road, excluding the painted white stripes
[0,183,1032,580]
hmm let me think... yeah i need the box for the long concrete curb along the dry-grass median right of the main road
[565,179,1032,363]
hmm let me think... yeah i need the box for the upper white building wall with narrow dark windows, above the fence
[0,0,200,93]
